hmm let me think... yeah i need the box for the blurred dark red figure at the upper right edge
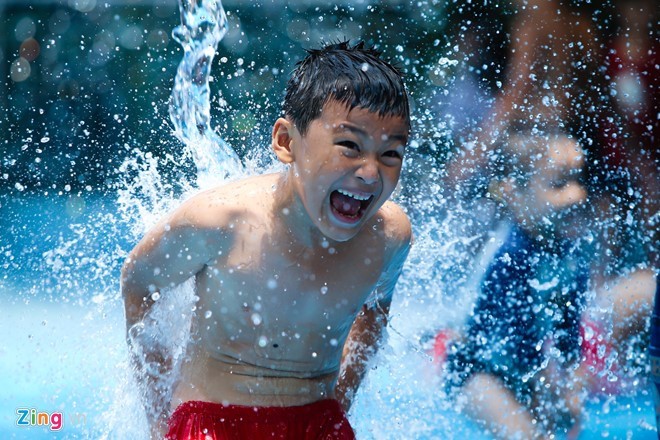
[601,0,660,267]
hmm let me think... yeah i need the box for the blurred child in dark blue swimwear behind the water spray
[447,128,588,438]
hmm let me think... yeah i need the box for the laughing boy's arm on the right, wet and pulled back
[335,212,412,412]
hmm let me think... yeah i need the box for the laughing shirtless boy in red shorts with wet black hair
[122,42,412,439]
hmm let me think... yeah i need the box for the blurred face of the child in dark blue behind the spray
[512,137,587,236]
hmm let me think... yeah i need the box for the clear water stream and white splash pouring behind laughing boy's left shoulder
[105,0,245,439]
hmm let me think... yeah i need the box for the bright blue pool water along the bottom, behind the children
[0,195,657,439]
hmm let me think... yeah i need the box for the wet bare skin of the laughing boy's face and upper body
[122,101,411,418]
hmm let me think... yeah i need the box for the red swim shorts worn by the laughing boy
[166,399,355,440]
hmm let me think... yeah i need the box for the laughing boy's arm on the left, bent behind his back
[121,201,217,437]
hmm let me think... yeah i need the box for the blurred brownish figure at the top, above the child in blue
[440,0,608,202]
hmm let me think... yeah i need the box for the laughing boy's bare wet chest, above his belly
[204,239,383,321]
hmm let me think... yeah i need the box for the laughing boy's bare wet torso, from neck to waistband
[173,176,398,406]
